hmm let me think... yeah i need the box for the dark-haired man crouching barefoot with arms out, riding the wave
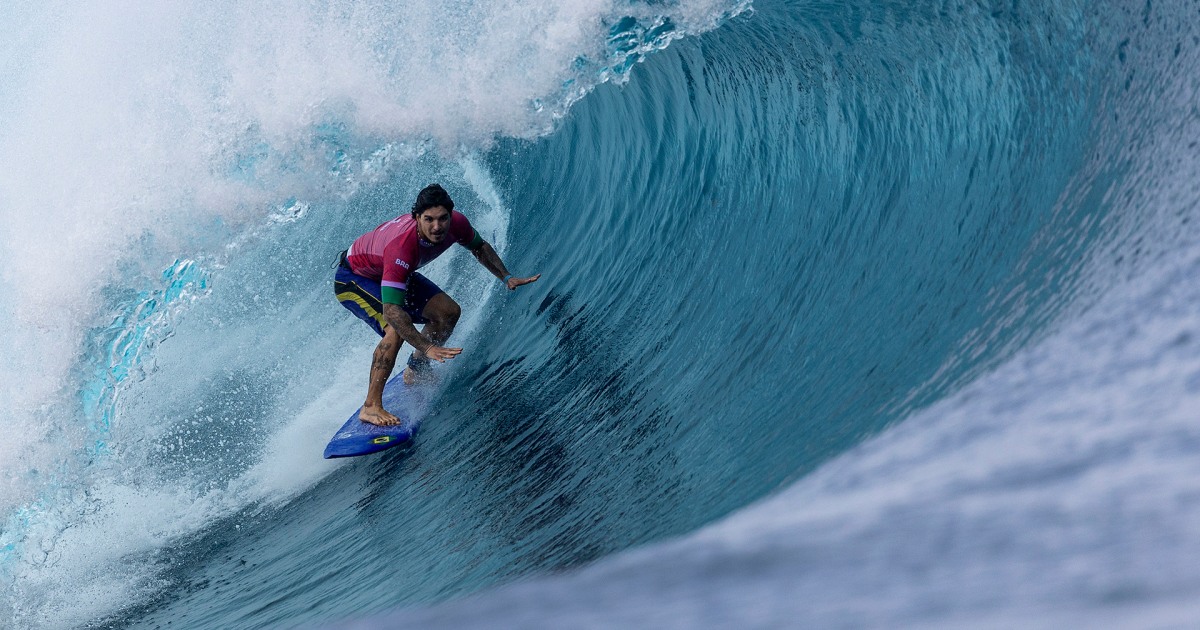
[334,184,541,426]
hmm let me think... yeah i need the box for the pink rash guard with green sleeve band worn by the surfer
[346,210,484,305]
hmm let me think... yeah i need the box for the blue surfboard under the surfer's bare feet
[325,371,431,460]
